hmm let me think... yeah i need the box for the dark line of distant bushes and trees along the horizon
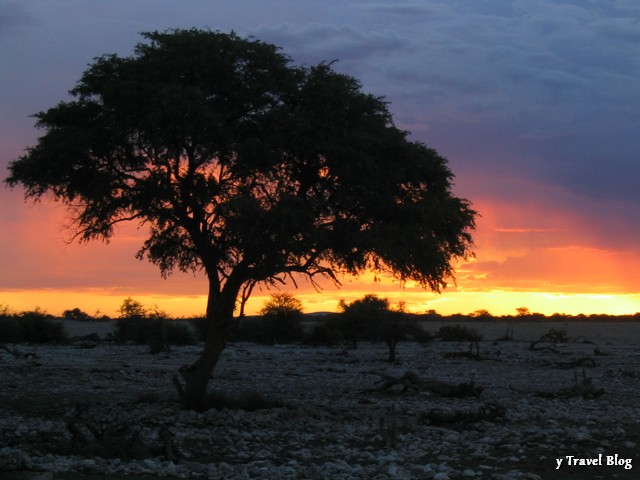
[0,298,640,350]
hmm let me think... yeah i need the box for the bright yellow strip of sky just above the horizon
[0,289,640,317]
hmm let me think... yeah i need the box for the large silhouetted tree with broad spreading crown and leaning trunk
[6,29,475,408]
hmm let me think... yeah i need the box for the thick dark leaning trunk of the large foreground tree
[180,284,236,410]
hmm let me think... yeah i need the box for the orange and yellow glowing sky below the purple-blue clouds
[0,179,640,317]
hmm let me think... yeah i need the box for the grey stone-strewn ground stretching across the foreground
[0,323,640,480]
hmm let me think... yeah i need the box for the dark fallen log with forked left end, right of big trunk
[361,371,484,397]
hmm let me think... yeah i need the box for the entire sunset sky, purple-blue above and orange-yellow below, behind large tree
[0,0,640,315]
